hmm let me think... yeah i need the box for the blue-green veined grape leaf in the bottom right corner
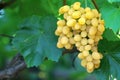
[93,52,120,80]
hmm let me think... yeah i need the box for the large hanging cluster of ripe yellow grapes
[55,2,105,73]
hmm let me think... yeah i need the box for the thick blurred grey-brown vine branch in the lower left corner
[0,54,26,79]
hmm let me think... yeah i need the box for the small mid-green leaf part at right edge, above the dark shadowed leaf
[103,28,120,41]
